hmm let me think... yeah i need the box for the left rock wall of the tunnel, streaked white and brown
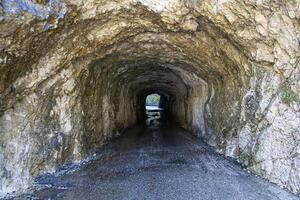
[0,60,136,195]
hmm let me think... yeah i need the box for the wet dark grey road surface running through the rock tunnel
[8,111,300,200]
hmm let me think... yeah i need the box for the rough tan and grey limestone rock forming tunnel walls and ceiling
[0,0,300,195]
